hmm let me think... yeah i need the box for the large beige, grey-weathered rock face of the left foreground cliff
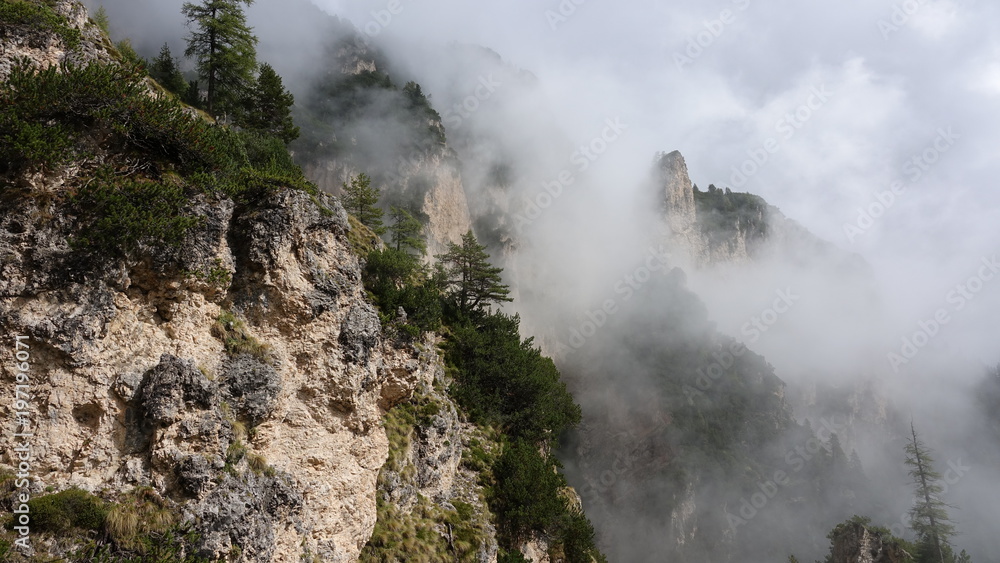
[0,180,436,561]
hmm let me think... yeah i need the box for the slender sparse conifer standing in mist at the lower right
[906,422,955,563]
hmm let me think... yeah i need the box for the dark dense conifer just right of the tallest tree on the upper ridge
[239,63,299,144]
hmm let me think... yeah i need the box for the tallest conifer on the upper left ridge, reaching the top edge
[181,0,257,116]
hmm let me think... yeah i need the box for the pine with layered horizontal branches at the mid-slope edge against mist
[437,229,513,316]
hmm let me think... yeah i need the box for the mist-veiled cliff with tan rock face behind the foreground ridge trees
[292,34,472,264]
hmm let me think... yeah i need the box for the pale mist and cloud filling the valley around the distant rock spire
[90,0,1000,561]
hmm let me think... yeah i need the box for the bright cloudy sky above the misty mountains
[306,0,1000,361]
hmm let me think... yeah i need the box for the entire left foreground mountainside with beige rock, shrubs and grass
[0,5,603,563]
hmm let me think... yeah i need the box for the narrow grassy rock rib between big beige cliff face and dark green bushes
[361,338,499,563]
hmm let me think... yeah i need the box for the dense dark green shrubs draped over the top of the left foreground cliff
[0,60,330,264]
